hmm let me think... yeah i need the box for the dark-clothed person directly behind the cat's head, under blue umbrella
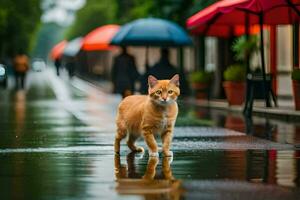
[141,48,178,94]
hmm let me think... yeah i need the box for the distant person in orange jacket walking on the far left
[13,53,29,89]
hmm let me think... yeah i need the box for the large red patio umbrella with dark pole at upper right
[187,0,300,107]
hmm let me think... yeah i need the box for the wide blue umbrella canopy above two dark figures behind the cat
[111,18,192,47]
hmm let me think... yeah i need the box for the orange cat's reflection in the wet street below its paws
[115,152,183,199]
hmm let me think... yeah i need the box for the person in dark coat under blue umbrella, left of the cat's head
[111,47,139,98]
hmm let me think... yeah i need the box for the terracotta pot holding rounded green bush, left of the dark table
[223,81,246,105]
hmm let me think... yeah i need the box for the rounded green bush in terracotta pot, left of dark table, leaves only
[224,64,246,82]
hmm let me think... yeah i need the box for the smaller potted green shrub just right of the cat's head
[190,71,212,99]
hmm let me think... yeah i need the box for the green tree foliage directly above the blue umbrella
[66,0,216,39]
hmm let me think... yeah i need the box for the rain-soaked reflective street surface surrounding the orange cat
[0,71,300,199]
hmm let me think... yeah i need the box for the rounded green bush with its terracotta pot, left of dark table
[223,64,246,105]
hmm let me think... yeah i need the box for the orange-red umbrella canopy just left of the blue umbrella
[82,24,120,51]
